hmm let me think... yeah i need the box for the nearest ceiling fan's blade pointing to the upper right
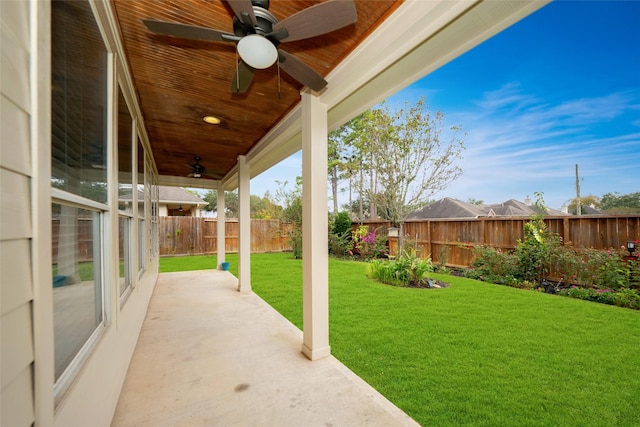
[273,0,358,42]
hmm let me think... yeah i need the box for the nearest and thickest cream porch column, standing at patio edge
[302,93,331,360]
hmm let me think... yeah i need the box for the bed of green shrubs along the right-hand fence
[465,196,640,310]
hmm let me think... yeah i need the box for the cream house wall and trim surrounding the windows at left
[0,0,158,427]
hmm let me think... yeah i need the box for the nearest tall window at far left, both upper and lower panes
[51,1,109,388]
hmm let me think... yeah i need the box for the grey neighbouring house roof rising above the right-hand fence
[407,197,567,219]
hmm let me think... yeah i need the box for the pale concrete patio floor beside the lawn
[112,270,418,427]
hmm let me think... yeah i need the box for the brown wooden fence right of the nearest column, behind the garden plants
[353,214,640,267]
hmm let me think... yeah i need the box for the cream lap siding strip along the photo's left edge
[0,1,35,427]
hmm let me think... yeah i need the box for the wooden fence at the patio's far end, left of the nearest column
[158,216,292,256]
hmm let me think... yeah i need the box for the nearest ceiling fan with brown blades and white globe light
[142,0,357,93]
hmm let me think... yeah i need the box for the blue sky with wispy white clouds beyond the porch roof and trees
[251,1,640,208]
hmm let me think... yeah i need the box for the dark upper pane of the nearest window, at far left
[51,1,108,203]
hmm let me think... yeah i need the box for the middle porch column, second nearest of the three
[238,156,251,292]
